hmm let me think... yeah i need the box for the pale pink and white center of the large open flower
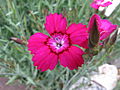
[47,33,70,53]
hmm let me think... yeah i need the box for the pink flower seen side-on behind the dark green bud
[88,14,117,40]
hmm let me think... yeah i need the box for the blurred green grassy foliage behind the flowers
[0,0,120,90]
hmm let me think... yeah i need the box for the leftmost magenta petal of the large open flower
[27,33,48,54]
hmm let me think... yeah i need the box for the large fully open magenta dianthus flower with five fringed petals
[28,13,88,71]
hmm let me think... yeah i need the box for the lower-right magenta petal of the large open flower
[59,46,84,70]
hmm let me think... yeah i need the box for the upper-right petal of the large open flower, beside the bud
[66,23,88,48]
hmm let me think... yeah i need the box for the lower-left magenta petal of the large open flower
[32,46,58,71]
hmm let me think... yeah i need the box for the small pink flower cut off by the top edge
[90,0,112,9]
